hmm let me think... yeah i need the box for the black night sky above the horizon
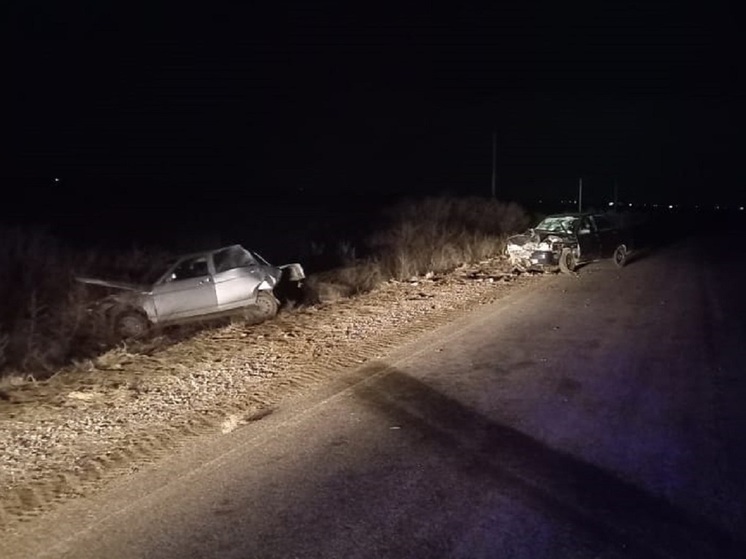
[0,0,745,233]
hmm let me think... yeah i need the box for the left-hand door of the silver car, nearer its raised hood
[153,255,217,322]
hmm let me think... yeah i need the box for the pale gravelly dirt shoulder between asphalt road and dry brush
[0,258,545,529]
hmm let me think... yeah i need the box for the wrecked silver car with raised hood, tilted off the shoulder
[76,245,305,339]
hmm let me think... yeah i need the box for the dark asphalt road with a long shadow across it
[5,230,746,559]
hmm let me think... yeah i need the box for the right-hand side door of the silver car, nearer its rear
[214,246,267,310]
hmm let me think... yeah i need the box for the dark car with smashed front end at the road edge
[506,213,632,273]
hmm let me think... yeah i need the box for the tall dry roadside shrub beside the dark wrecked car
[369,196,529,280]
